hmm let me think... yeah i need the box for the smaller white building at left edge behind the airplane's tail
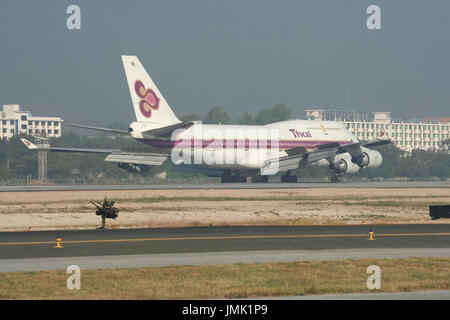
[0,104,63,139]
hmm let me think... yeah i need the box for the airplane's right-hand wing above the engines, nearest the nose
[261,139,391,175]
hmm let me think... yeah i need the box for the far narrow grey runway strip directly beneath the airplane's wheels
[0,181,450,192]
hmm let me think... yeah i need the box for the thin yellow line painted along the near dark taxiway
[0,233,450,246]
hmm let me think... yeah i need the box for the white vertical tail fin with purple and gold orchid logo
[122,56,181,126]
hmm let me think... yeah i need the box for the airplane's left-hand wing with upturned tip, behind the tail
[21,139,169,166]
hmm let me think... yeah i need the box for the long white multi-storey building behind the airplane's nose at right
[305,109,450,152]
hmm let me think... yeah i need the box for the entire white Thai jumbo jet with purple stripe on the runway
[22,56,390,182]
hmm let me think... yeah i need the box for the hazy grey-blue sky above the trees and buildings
[0,0,450,125]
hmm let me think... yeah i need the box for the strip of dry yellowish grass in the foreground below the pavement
[0,258,450,299]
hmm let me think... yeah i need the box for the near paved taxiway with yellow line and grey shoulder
[0,224,450,272]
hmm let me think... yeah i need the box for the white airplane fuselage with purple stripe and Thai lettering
[131,120,358,170]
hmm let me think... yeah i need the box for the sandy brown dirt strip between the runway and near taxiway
[0,188,450,231]
